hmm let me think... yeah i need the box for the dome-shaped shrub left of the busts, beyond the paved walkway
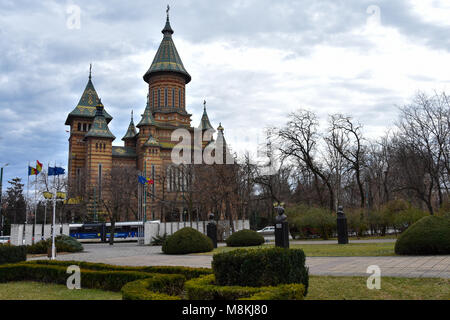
[162,227,213,254]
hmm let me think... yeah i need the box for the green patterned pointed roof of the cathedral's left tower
[66,74,112,125]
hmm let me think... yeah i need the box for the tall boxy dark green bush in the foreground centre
[212,248,309,294]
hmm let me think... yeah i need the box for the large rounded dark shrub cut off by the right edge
[395,216,450,255]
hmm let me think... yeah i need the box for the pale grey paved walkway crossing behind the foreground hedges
[32,240,450,278]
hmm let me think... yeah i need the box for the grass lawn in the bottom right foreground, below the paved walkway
[306,276,450,300]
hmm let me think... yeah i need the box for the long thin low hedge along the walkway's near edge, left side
[25,260,212,280]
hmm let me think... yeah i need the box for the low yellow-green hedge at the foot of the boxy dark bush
[184,274,305,300]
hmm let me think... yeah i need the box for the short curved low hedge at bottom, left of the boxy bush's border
[121,274,186,300]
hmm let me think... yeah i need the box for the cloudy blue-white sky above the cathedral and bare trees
[0,0,450,186]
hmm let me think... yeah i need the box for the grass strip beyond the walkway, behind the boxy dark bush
[197,242,395,257]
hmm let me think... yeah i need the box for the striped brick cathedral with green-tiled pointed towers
[65,10,223,219]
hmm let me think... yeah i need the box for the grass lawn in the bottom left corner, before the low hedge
[0,281,122,300]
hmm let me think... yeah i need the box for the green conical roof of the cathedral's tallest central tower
[144,16,191,83]
